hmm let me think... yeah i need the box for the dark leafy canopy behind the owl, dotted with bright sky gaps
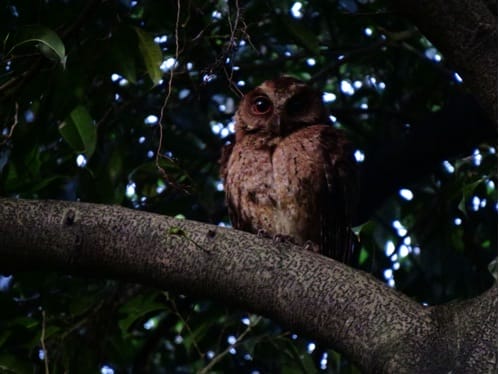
[0,0,497,373]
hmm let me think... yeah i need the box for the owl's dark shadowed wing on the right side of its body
[319,127,358,263]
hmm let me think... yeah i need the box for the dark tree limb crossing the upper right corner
[392,0,497,123]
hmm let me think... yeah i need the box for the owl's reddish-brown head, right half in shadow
[235,76,329,138]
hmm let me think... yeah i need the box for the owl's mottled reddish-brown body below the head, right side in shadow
[221,125,356,261]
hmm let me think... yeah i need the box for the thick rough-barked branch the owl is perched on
[0,199,497,373]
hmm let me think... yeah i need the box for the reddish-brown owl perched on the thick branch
[220,76,357,262]
